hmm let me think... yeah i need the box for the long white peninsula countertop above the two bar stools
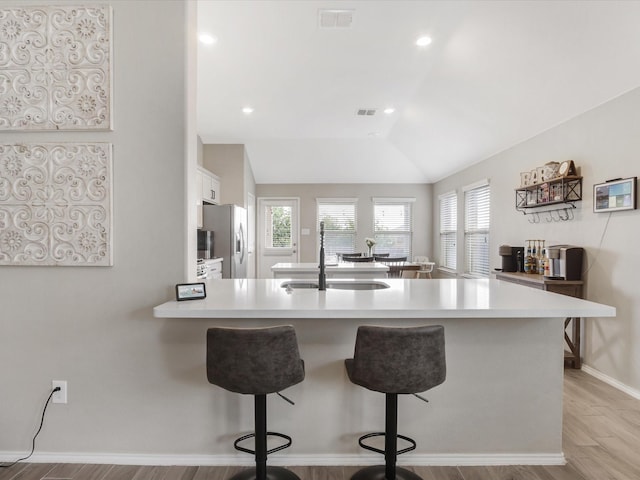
[153,278,616,318]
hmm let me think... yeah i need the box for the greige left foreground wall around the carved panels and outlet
[0,0,190,460]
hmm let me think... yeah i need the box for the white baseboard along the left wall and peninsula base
[0,452,566,466]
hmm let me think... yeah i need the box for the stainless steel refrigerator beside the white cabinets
[202,205,247,278]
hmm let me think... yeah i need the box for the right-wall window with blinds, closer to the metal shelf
[464,181,490,277]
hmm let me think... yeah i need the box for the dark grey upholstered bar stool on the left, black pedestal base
[207,325,304,480]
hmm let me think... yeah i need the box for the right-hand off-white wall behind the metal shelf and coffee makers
[433,89,640,390]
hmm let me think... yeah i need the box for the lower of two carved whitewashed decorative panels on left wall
[0,143,113,266]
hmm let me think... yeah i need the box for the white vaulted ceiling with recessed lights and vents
[198,0,640,183]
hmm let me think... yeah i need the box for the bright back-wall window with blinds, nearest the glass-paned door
[317,198,357,256]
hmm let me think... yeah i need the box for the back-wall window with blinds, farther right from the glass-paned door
[373,198,415,259]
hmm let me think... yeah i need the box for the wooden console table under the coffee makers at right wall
[496,272,584,368]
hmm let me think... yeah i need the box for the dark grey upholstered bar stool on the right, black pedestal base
[345,325,446,480]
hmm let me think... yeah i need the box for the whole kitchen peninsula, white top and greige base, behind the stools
[154,279,615,465]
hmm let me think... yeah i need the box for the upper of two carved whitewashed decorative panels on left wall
[0,6,112,130]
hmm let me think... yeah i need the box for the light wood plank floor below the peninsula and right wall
[0,370,640,480]
